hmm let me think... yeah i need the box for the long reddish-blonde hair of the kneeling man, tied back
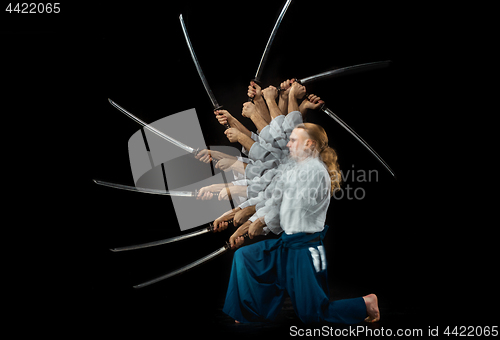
[295,123,342,195]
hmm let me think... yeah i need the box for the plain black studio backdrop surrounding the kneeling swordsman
[1,0,498,336]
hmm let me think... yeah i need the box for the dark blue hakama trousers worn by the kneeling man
[223,226,367,324]
